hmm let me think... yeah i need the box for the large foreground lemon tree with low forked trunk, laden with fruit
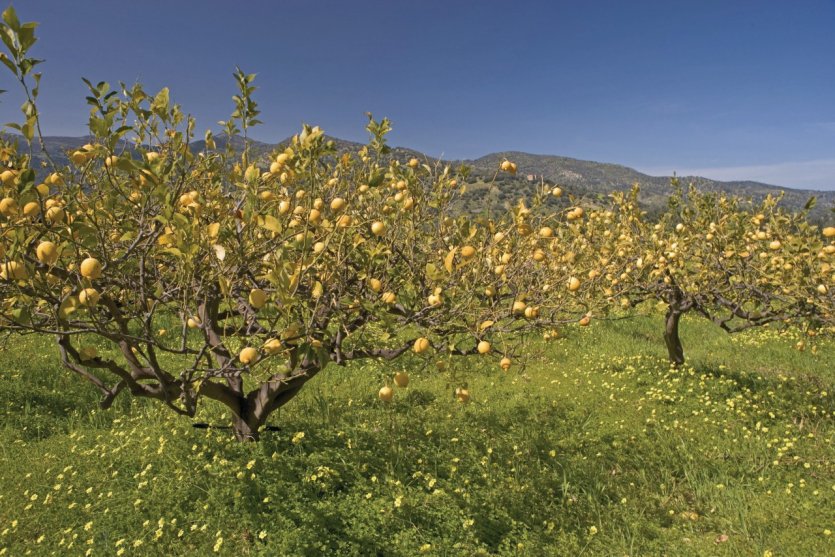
[0,8,629,440]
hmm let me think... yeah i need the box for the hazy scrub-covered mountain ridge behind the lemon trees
[8,136,835,223]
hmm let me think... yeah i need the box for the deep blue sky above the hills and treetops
[0,0,835,189]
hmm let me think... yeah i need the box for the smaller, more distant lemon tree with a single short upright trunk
[631,181,835,365]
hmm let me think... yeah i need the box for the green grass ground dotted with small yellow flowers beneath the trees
[0,317,835,556]
